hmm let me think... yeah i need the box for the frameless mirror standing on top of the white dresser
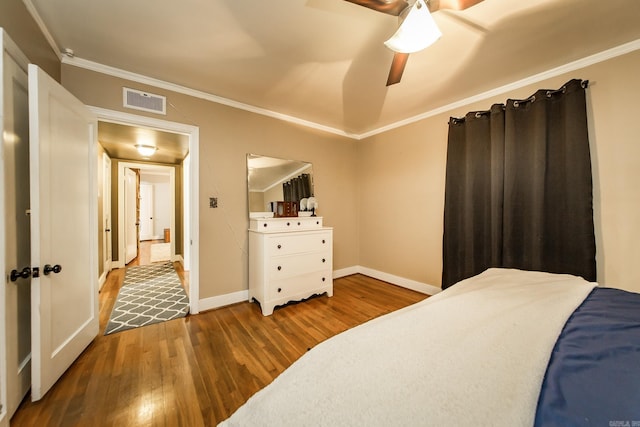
[247,154,313,218]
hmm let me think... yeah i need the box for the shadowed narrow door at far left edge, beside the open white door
[0,34,31,418]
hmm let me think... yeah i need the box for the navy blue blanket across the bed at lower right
[535,288,640,427]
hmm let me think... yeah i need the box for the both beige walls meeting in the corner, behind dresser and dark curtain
[63,52,640,298]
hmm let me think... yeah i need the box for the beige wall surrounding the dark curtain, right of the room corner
[358,51,640,292]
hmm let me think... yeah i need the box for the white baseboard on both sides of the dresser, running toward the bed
[198,265,442,311]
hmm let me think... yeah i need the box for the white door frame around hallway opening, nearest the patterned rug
[88,106,200,314]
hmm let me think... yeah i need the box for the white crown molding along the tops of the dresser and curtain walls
[60,37,640,140]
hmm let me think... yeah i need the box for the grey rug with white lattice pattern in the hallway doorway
[104,262,189,335]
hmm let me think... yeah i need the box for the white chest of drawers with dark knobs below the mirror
[249,217,333,316]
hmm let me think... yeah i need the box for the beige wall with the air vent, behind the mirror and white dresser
[62,65,358,298]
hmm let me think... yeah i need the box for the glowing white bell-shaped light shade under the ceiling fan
[384,0,442,53]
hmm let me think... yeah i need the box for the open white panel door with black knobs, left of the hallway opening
[29,64,99,401]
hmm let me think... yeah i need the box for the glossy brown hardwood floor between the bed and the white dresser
[11,269,426,427]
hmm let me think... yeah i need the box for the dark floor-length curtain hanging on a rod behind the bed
[442,80,596,289]
